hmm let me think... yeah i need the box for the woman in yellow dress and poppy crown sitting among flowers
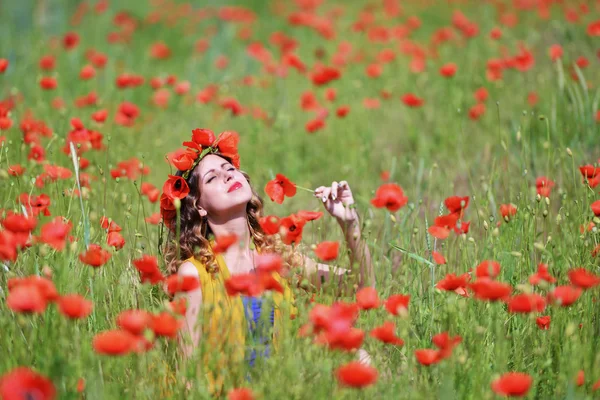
[161,129,374,393]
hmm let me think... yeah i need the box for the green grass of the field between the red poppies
[0,1,600,399]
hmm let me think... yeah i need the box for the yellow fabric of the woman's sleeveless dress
[165,247,297,394]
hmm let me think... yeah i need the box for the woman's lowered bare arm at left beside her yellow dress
[178,261,202,359]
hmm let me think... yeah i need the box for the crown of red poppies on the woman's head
[160,128,240,230]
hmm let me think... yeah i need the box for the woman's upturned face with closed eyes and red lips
[198,154,252,216]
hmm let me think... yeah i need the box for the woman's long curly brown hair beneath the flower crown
[164,152,304,274]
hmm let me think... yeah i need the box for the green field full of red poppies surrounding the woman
[0,0,600,400]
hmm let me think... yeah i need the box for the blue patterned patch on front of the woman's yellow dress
[241,296,275,367]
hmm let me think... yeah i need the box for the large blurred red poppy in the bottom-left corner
[0,367,56,400]
